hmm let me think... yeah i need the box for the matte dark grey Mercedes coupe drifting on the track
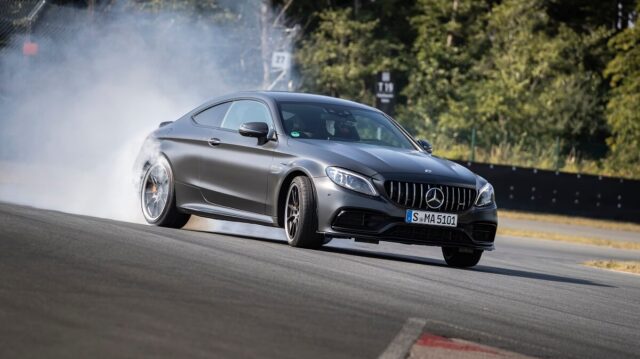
[137,92,497,267]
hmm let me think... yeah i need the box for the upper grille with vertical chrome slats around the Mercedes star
[384,181,476,212]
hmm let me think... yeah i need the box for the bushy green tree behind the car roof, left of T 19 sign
[297,9,402,104]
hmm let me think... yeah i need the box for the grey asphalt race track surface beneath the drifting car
[0,204,640,358]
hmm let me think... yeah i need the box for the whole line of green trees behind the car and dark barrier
[288,0,640,177]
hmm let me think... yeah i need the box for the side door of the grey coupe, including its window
[200,100,276,214]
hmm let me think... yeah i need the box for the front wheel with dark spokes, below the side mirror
[284,176,324,248]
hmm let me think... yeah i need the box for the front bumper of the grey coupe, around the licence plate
[313,177,498,250]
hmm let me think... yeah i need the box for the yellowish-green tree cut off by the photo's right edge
[604,4,640,177]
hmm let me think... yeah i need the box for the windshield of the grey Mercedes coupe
[279,102,414,149]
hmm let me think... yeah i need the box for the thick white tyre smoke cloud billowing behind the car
[0,1,290,239]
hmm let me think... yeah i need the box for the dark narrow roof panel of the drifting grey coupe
[212,91,378,111]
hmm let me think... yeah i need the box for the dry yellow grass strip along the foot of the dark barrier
[498,210,640,233]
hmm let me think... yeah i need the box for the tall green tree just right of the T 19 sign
[400,0,489,136]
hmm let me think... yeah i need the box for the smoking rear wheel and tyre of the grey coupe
[140,156,191,228]
